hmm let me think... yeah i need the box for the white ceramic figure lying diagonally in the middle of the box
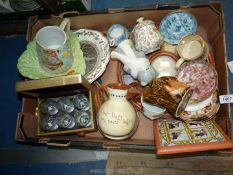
[111,40,156,86]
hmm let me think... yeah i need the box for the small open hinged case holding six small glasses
[16,74,96,136]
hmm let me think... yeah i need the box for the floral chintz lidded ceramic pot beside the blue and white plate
[133,17,163,54]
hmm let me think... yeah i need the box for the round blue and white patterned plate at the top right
[159,11,197,44]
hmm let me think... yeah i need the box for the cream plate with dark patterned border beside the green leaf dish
[75,29,110,83]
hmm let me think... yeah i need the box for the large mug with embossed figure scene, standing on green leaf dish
[36,18,73,74]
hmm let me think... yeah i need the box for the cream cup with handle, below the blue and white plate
[176,35,206,68]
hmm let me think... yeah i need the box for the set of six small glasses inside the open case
[38,94,91,132]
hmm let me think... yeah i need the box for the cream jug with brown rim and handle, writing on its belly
[97,84,138,140]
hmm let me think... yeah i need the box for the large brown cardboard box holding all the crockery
[16,3,232,151]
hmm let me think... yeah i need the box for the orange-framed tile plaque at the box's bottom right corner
[154,118,233,154]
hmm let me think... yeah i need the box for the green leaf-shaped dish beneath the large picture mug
[17,32,86,79]
